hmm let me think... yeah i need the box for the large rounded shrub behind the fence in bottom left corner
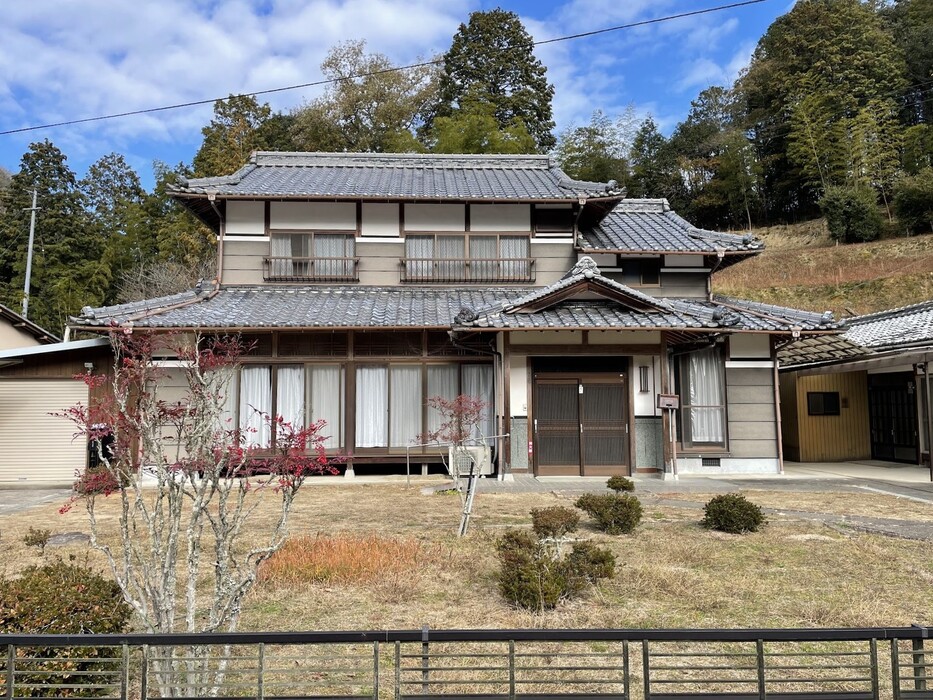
[0,561,132,697]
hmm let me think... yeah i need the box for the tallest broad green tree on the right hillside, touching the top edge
[738,0,906,218]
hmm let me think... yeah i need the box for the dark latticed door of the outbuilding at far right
[868,372,919,464]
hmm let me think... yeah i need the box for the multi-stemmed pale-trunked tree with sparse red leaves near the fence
[63,331,332,697]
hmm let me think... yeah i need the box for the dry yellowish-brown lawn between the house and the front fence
[0,484,933,630]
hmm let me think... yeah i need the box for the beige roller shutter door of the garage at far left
[0,379,87,486]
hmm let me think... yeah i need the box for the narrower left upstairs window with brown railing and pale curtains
[266,232,357,282]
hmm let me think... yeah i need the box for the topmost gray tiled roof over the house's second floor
[172,151,623,200]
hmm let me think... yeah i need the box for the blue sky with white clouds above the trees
[0,0,793,187]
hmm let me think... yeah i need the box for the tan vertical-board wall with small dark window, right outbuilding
[796,372,871,462]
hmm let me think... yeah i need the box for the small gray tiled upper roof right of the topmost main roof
[581,199,764,255]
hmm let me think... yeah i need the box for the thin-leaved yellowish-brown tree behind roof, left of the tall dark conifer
[291,41,438,153]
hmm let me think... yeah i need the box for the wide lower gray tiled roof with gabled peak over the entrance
[72,258,837,333]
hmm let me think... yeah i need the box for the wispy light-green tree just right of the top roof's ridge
[555,110,630,185]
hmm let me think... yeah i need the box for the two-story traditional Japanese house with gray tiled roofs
[65,153,836,476]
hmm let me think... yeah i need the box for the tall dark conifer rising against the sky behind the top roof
[434,8,556,153]
